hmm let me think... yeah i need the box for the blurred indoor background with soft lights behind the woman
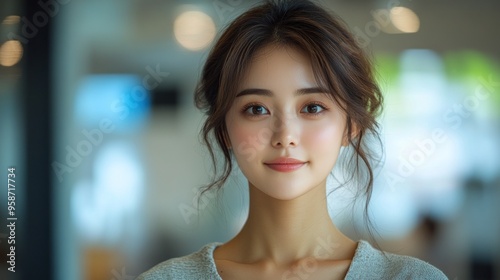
[0,0,500,280]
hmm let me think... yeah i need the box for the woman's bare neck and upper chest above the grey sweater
[228,182,355,265]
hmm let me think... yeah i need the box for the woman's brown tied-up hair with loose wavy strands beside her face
[195,0,382,219]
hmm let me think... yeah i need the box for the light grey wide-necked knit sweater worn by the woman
[137,240,448,280]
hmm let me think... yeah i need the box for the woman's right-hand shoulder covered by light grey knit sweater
[346,241,448,280]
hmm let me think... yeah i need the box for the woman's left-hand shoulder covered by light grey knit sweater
[137,243,220,280]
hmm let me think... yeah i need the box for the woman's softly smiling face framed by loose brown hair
[226,46,346,200]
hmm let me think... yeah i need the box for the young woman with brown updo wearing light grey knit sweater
[139,0,447,280]
